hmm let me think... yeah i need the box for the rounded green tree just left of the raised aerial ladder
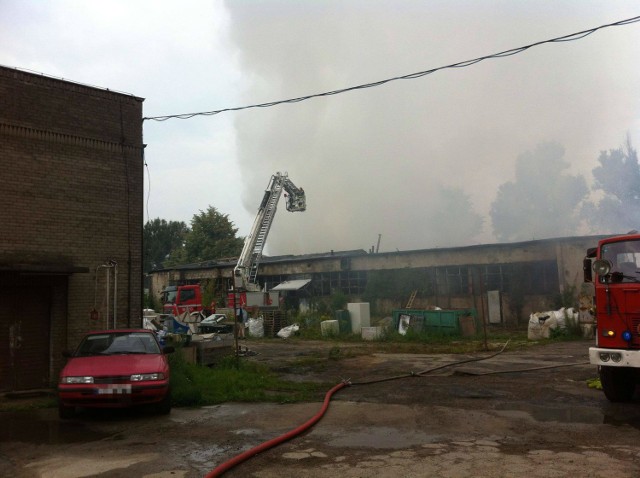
[180,206,244,263]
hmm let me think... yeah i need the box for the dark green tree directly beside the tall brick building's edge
[142,218,189,272]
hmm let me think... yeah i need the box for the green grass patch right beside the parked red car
[170,354,320,406]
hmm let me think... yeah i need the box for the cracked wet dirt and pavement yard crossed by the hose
[0,340,640,478]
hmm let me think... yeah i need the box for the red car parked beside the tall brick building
[58,329,174,418]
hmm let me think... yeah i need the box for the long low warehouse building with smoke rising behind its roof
[150,236,604,324]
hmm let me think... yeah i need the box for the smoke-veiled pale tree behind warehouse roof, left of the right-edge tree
[490,143,588,242]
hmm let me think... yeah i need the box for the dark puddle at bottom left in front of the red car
[0,412,109,444]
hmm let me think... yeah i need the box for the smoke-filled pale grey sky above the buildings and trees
[0,0,640,255]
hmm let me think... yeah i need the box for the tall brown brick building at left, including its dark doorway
[0,66,143,391]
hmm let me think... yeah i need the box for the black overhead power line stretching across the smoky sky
[142,16,640,121]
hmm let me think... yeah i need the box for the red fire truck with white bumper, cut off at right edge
[583,231,640,402]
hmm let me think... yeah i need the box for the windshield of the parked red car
[76,332,160,357]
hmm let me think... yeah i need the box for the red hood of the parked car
[61,354,168,377]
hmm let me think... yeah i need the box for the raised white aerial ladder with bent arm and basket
[233,172,307,292]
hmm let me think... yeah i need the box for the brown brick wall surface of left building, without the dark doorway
[0,67,143,352]
